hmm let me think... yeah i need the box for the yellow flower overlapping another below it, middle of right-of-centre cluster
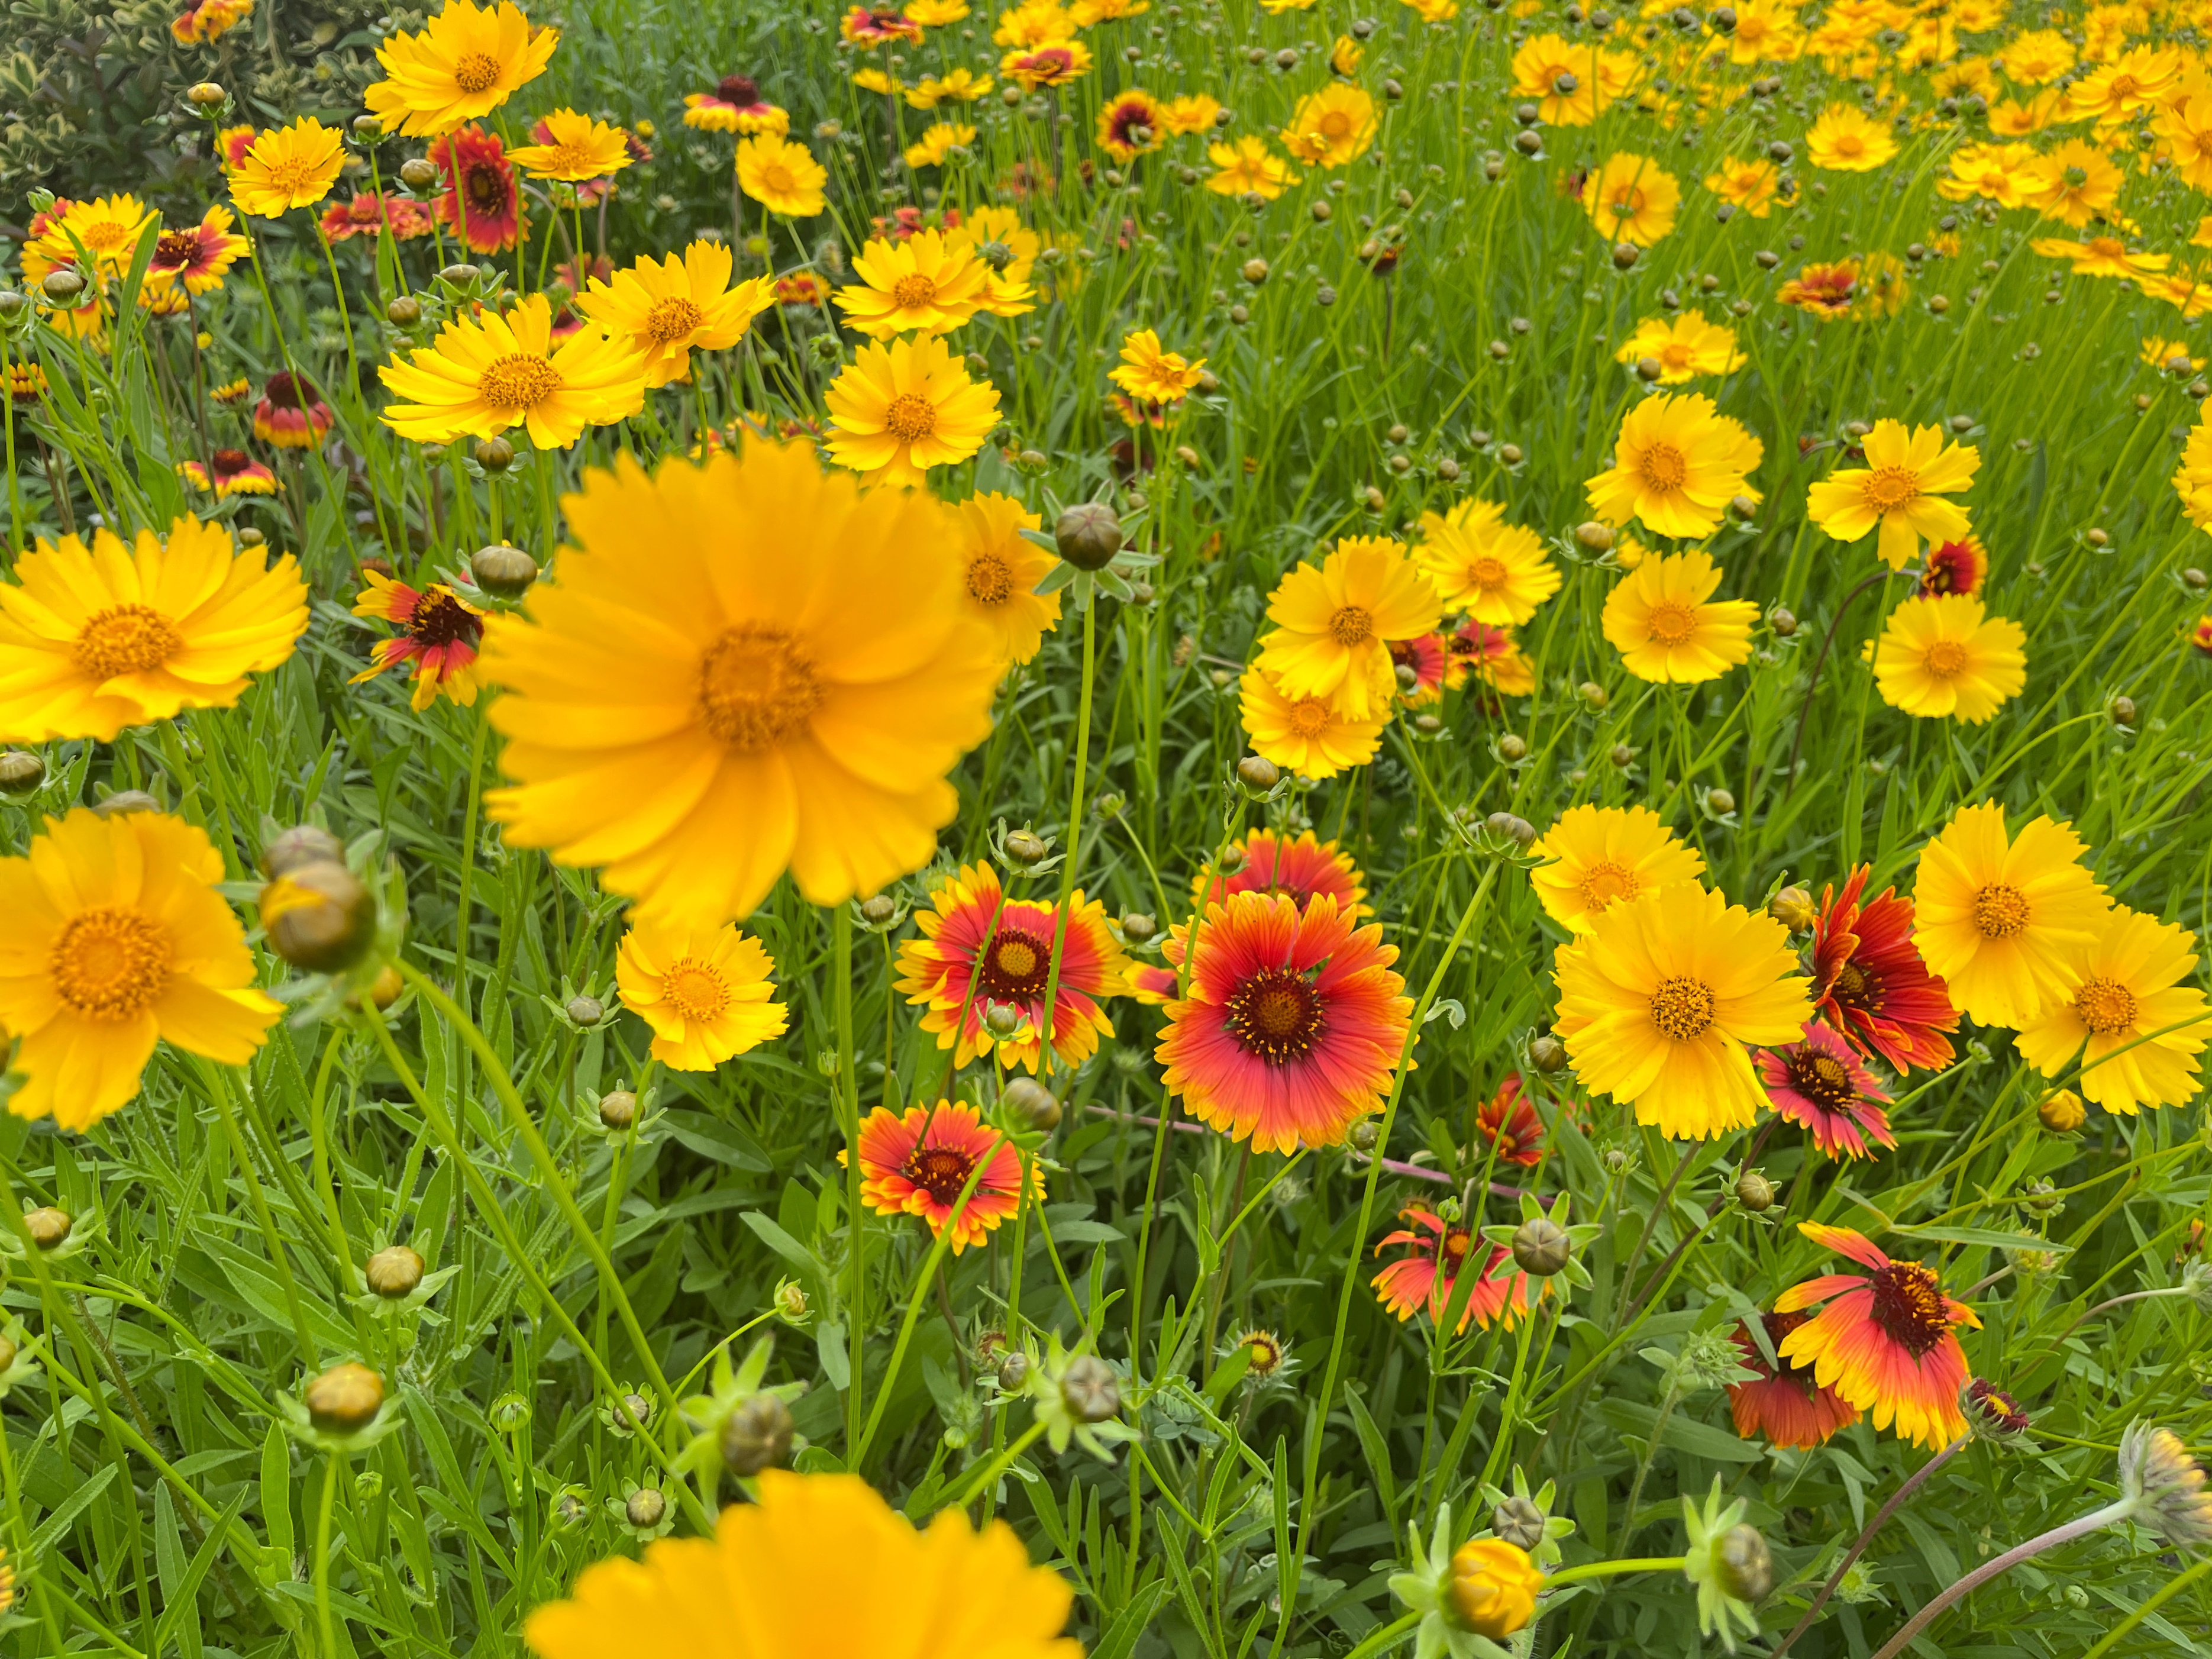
[1257,535,1445,724]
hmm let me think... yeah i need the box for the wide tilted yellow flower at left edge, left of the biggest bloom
[0,518,308,743]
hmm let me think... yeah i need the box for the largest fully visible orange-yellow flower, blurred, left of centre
[482,438,1000,922]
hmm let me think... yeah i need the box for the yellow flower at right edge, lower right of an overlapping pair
[2015,905,2212,1117]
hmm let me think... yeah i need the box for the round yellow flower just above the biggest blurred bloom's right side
[823,336,997,485]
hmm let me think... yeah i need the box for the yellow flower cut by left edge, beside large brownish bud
[0,808,283,1130]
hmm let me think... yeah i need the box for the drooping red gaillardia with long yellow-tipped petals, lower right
[1774,1221,1982,1447]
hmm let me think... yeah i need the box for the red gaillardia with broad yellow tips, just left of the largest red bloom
[898,865,1128,1071]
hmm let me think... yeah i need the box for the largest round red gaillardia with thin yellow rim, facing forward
[1159,893,1413,1153]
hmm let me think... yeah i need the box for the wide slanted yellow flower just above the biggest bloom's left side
[378,294,646,449]
